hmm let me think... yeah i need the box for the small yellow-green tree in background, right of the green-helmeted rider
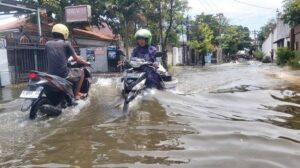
[188,23,213,54]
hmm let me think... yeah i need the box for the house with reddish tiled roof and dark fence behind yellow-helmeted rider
[0,19,116,85]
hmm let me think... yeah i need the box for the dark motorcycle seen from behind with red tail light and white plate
[20,61,92,119]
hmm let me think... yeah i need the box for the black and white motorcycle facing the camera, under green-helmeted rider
[121,52,172,112]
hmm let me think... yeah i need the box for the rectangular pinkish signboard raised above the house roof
[65,5,91,23]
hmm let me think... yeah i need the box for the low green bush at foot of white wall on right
[277,48,295,66]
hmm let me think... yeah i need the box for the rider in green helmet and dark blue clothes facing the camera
[131,29,162,89]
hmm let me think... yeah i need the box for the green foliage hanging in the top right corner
[282,0,300,26]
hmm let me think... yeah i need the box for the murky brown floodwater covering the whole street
[0,62,300,168]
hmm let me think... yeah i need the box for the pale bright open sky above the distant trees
[188,0,282,31]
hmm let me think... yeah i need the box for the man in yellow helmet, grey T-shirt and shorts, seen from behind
[45,24,90,100]
